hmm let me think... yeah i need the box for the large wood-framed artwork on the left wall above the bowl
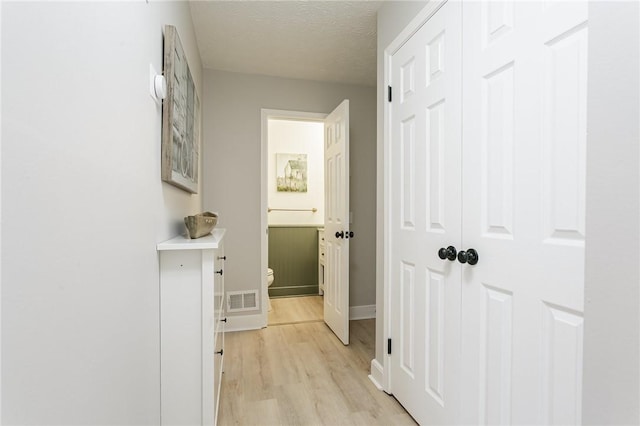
[161,25,200,194]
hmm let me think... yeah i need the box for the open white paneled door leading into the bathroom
[324,100,353,345]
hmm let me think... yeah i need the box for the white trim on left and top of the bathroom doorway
[260,108,328,328]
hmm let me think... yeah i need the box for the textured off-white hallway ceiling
[190,0,382,86]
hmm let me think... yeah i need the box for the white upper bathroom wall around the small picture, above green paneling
[267,120,324,226]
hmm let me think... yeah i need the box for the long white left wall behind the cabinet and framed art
[0,1,202,425]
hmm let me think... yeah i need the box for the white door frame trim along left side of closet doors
[376,0,447,394]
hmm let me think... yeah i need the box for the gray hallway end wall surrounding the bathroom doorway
[203,70,376,314]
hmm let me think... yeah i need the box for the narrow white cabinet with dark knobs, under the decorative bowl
[157,229,226,425]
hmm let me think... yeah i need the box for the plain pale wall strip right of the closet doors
[582,2,640,425]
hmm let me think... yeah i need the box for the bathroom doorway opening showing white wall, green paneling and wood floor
[261,110,326,325]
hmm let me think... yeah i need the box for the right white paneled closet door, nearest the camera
[461,1,587,424]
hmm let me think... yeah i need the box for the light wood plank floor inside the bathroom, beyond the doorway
[268,296,324,325]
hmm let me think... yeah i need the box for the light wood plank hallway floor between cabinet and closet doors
[218,299,416,426]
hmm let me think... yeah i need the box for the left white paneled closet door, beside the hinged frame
[389,1,461,424]
